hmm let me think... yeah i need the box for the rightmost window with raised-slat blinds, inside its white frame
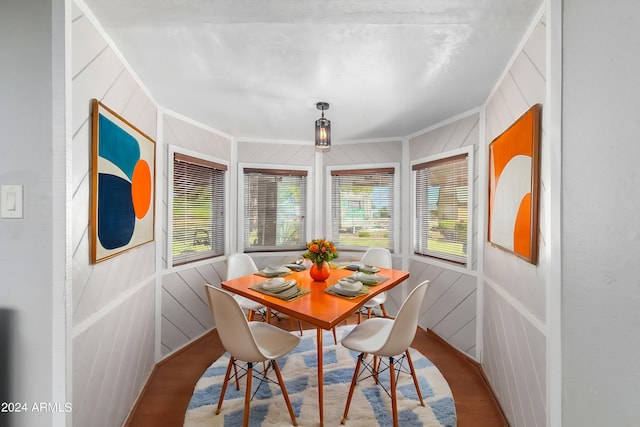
[413,153,469,265]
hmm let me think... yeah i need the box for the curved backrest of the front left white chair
[204,284,267,362]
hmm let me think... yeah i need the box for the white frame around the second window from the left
[237,163,314,255]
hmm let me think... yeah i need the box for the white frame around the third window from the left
[325,162,402,254]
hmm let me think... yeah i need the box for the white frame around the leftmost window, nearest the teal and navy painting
[168,144,230,268]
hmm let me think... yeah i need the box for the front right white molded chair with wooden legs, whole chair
[341,280,429,427]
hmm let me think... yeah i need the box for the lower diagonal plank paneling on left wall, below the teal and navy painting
[73,283,155,425]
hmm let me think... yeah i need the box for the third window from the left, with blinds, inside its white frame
[331,167,395,251]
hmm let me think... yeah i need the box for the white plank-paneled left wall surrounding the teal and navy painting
[71,4,156,425]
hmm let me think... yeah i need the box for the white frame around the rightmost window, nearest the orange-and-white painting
[409,145,477,270]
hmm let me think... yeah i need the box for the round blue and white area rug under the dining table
[184,326,456,427]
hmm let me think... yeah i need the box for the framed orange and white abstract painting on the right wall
[487,104,542,265]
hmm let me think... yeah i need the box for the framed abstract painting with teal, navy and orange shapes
[90,99,155,264]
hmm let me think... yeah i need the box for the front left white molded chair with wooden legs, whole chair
[205,284,300,427]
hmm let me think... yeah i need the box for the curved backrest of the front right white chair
[376,280,429,357]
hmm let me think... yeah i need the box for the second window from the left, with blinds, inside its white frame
[243,168,307,252]
